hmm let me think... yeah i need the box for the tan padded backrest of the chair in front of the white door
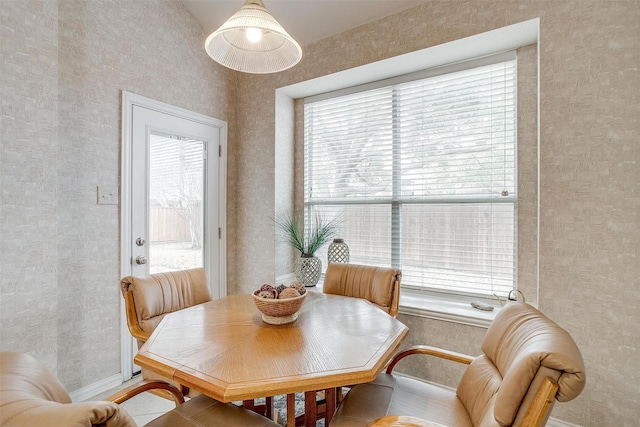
[120,268,211,345]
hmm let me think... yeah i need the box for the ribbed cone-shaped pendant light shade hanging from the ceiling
[204,0,302,74]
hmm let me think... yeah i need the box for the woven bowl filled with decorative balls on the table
[253,282,307,325]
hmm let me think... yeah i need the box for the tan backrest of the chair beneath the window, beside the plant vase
[322,263,402,317]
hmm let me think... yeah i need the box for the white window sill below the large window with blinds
[399,290,500,328]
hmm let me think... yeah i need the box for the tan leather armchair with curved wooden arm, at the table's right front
[330,302,585,427]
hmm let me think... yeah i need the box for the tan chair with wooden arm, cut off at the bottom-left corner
[0,352,278,427]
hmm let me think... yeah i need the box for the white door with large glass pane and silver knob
[121,92,226,380]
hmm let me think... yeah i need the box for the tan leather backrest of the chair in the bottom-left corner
[0,352,136,427]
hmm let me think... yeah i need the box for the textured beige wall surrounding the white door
[0,0,235,391]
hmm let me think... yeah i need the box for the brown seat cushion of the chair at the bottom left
[146,395,279,427]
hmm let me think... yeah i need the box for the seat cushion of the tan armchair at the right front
[331,373,473,427]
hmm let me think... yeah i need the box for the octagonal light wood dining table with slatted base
[134,291,408,427]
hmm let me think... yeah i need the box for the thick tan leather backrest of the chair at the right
[457,302,585,427]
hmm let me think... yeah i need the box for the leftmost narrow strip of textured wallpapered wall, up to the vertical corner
[0,1,59,371]
